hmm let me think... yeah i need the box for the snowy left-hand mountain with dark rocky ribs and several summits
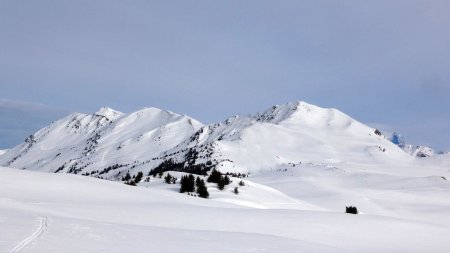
[0,108,202,179]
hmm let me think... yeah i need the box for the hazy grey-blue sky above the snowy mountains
[0,0,450,149]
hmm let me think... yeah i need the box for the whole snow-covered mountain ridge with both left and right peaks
[0,102,411,180]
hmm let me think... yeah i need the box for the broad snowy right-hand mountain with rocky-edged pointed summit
[177,101,411,172]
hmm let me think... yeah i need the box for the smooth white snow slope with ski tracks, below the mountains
[0,166,450,252]
